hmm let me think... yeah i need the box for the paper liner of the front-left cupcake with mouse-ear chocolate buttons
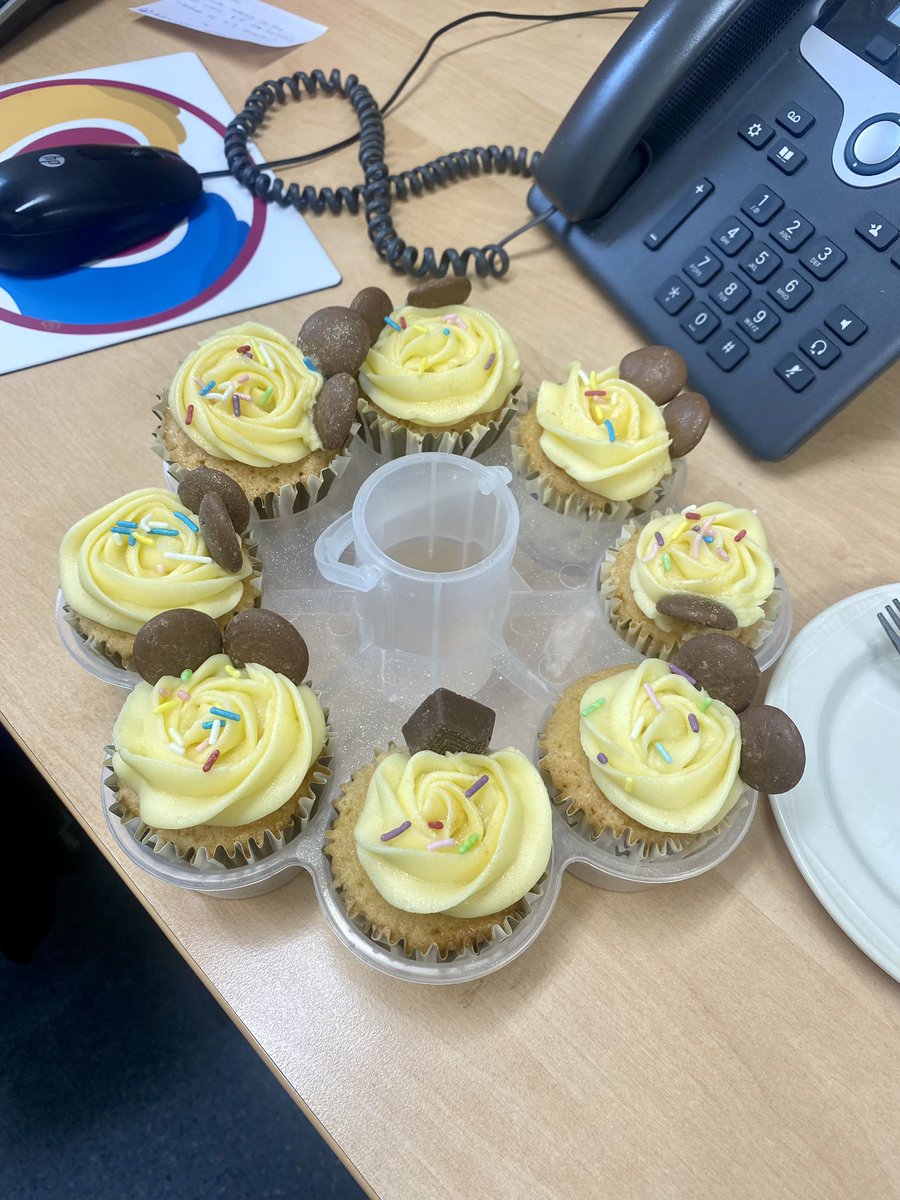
[103,692,332,871]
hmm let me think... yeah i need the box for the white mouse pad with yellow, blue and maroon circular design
[0,53,341,374]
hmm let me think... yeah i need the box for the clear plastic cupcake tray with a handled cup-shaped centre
[84,433,791,983]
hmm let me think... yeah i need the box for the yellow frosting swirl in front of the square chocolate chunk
[355,748,552,917]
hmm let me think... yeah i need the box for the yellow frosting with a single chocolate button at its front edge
[630,500,775,632]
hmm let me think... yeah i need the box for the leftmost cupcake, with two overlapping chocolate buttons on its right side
[59,470,259,671]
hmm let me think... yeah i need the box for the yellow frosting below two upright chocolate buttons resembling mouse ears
[113,654,325,829]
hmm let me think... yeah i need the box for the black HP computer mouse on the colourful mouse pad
[0,145,203,275]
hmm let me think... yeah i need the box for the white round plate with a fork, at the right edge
[767,583,900,980]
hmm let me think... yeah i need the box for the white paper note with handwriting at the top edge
[131,0,328,46]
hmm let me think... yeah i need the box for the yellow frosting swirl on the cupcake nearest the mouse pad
[169,323,323,467]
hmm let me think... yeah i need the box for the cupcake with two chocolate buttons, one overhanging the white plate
[539,634,805,857]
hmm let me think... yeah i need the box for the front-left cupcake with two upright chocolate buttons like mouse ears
[108,610,329,866]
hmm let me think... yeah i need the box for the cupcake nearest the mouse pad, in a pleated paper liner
[155,323,365,517]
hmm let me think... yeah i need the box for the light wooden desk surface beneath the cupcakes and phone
[0,0,900,1200]
